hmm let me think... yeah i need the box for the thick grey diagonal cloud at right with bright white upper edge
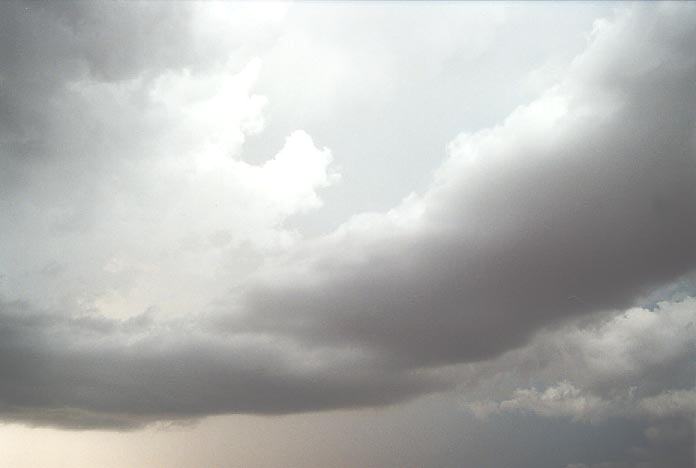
[235,5,696,368]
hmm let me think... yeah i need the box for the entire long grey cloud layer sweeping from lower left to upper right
[0,1,696,434]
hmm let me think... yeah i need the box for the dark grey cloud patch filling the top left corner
[0,2,190,159]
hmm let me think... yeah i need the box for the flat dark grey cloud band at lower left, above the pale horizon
[0,303,445,428]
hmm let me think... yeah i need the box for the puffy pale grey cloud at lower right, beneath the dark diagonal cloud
[460,298,696,423]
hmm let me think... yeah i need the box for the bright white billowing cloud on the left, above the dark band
[0,32,338,316]
